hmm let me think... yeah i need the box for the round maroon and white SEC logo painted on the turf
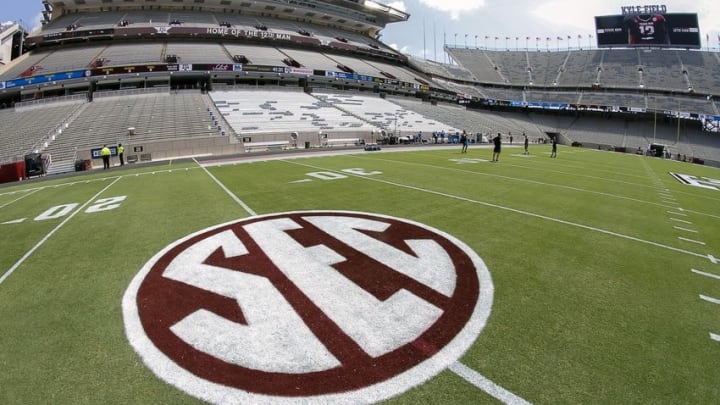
[122,211,493,404]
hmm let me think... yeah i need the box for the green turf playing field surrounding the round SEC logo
[0,146,720,404]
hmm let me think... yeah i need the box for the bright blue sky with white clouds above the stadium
[0,0,720,62]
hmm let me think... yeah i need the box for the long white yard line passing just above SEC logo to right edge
[284,160,708,259]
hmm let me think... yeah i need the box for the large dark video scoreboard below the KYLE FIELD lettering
[595,12,700,49]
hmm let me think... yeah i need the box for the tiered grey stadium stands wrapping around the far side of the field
[0,0,720,175]
